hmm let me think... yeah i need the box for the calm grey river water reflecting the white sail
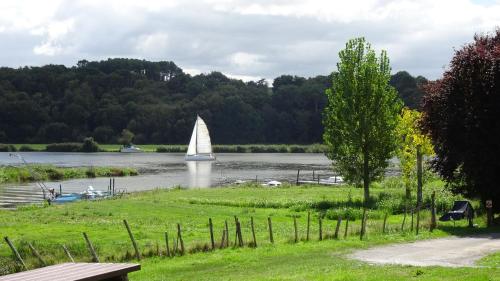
[0,152,332,207]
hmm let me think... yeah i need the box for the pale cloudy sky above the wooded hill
[0,0,500,81]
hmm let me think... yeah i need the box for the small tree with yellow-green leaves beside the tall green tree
[396,108,434,195]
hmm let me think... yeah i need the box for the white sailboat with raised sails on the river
[185,115,215,161]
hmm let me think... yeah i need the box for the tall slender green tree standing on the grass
[323,38,401,206]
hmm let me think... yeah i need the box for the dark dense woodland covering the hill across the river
[0,59,427,144]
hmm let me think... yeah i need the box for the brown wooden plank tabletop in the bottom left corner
[0,263,141,281]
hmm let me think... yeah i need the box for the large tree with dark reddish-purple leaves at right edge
[422,29,500,211]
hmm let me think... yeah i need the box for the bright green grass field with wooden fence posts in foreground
[0,179,500,280]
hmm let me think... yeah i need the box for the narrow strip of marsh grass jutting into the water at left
[0,164,138,183]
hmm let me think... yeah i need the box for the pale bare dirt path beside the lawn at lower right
[351,233,500,267]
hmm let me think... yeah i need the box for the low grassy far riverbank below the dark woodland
[4,143,326,153]
